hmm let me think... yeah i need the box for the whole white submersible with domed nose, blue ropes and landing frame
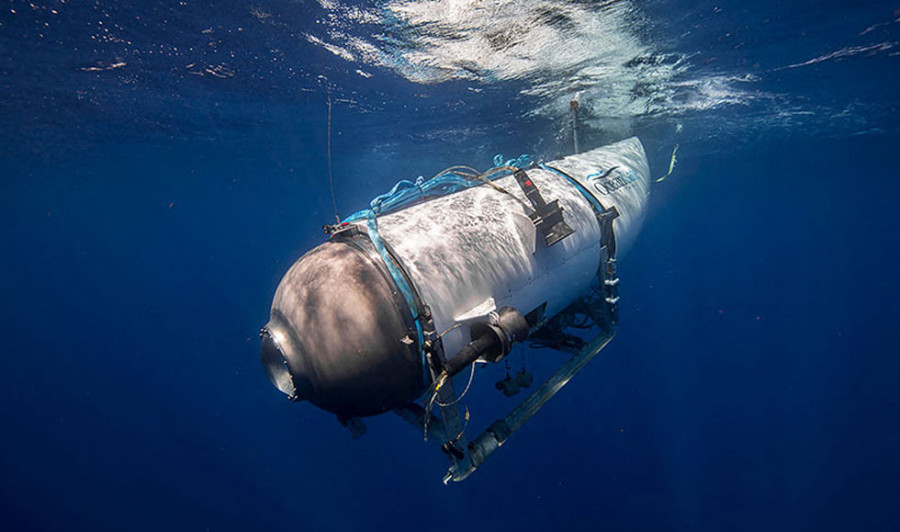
[261,137,650,480]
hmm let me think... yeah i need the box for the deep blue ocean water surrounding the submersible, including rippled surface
[0,0,900,531]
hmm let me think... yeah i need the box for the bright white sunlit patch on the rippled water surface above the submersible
[309,0,765,130]
